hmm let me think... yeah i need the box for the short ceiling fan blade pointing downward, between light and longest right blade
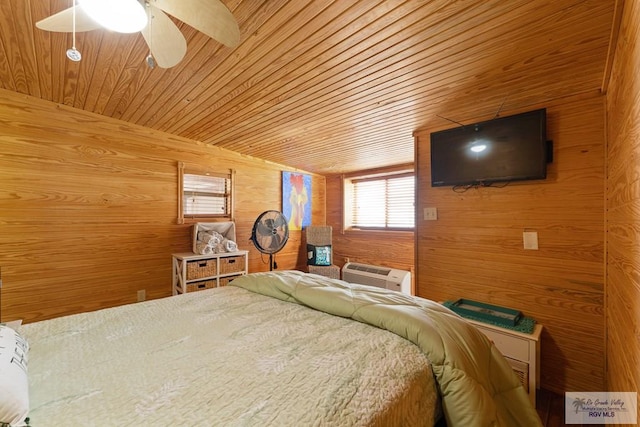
[140,5,187,68]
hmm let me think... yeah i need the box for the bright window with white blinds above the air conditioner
[344,172,415,230]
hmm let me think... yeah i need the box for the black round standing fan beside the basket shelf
[251,210,289,271]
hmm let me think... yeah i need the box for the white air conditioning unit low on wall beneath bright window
[342,262,411,294]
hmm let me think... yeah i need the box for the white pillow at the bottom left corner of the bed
[0,325,29,426]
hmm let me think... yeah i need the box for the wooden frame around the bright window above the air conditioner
[341,165,417,233]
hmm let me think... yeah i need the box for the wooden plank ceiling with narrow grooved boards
[0,0,615,174]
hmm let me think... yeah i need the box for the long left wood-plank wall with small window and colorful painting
[0,90,326,322]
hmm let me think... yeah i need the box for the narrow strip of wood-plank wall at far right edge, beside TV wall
[606,1,640,402]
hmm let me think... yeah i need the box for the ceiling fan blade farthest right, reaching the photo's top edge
[152,0,240,47]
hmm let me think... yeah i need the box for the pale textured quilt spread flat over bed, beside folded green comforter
[20,275,440,427]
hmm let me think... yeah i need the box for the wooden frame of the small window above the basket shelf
[177,162,235,224]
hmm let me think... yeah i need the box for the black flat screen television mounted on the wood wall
[431,108,550,187]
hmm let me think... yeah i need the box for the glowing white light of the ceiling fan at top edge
[78,0,147,33]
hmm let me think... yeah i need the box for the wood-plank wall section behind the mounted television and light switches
[416,94,605,393]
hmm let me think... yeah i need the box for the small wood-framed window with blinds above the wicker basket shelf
[178,163,233,223]
